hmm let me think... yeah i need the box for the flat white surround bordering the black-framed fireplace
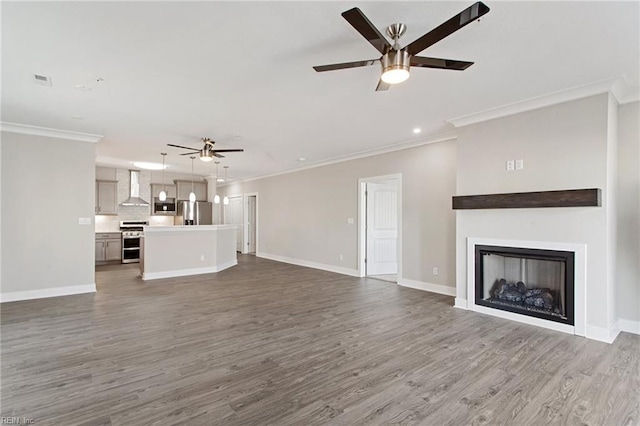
[456,237,587,336]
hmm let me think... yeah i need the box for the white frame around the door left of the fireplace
[358,173,402,282]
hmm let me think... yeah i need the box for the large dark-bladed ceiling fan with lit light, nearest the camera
[313,2,489,91]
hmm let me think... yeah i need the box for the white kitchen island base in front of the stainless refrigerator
[140,225,238,280]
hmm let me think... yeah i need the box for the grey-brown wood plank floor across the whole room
[1,256,640,425]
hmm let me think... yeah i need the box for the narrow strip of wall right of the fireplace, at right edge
[616,102,640,324]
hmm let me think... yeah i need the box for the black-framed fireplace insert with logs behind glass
[474,245,575,326]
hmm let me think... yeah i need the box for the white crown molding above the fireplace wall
[446,76,640,128]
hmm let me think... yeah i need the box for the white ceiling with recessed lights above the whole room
[2,1,640,179]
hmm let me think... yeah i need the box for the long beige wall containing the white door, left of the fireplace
[219,140,456,291]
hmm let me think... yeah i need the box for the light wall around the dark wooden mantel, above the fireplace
[456,94,616,335]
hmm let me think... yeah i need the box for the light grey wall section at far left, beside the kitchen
[1,132,95,301]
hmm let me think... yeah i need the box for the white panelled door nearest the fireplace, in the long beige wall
[366,182,398,275]
